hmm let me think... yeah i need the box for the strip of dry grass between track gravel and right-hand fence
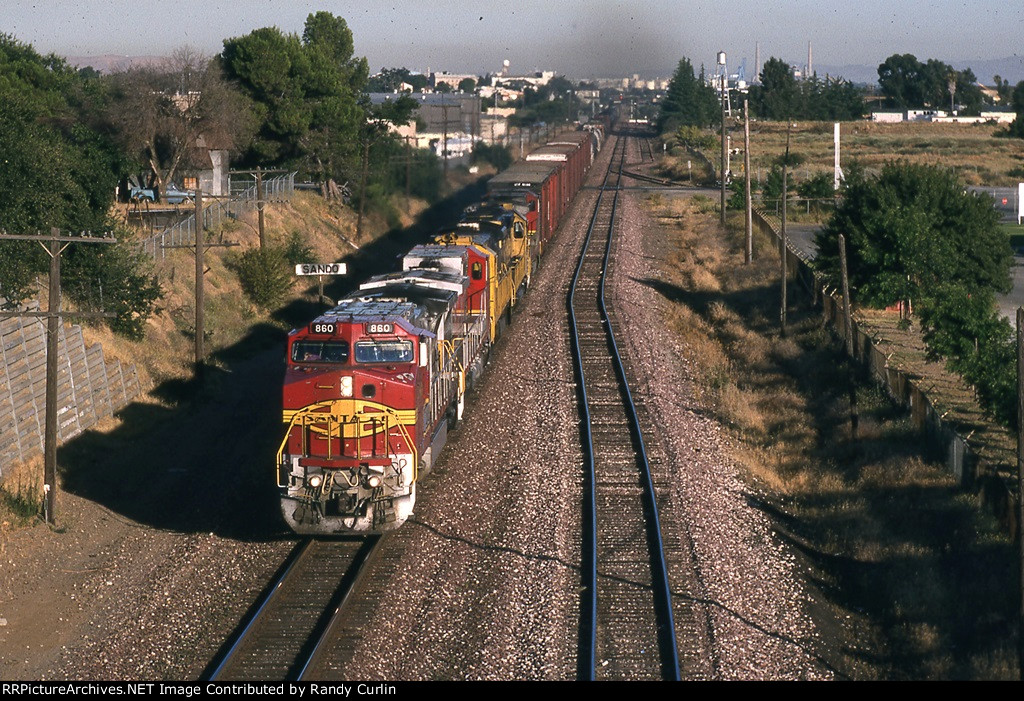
[650,192,1017,678]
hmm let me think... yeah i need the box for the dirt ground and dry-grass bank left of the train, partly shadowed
[0,179,491,680]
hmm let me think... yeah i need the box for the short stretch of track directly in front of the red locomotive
[207,535,381,682]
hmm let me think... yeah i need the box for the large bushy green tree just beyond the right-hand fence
[816,163,1017,425]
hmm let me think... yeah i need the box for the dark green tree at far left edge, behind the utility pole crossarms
[0,35,160,336]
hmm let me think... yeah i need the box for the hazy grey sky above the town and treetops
[8,0,1024,78]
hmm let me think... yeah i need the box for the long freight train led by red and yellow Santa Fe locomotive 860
[276,129,603,534]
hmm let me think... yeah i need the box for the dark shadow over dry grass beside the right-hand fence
[637,268,1016,680]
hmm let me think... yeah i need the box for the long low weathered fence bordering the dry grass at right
[754,210,1017,533]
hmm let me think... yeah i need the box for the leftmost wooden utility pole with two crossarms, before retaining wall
[0,227,118,525]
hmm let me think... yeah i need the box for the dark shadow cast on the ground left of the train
[57,181,484,539]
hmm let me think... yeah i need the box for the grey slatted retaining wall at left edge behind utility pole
[0,303,141,483]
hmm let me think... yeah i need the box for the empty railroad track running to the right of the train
[568,130,680,680]
